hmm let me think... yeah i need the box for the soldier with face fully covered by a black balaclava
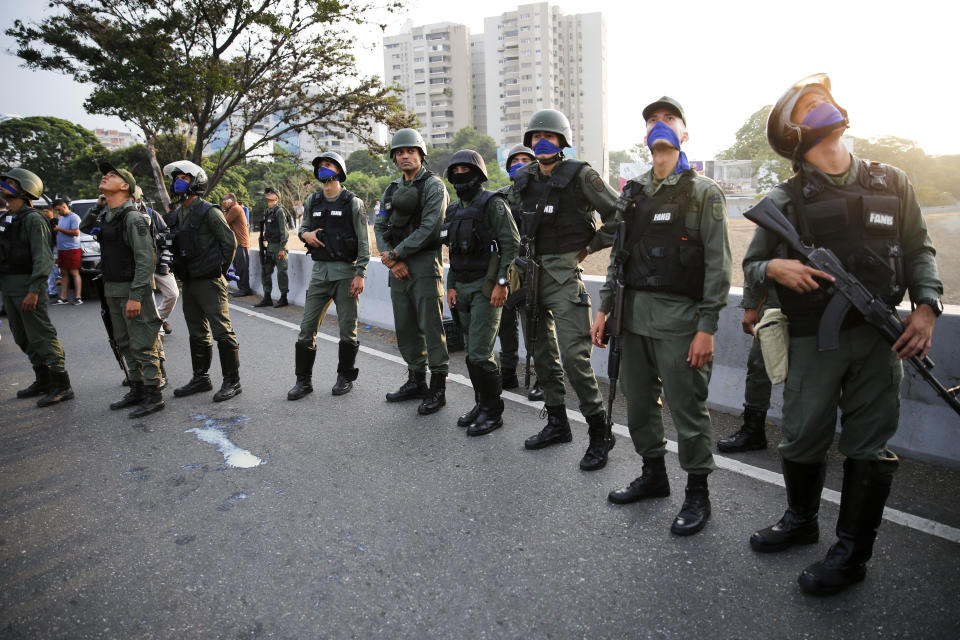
[440,149,520,436]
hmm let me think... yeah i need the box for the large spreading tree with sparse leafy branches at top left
[7,0,412,208]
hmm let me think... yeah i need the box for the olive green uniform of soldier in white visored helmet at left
[177,197,239,346]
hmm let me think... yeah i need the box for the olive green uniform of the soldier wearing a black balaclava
[447,192,520,373]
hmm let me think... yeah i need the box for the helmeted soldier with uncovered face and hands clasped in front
[374,129,450,415]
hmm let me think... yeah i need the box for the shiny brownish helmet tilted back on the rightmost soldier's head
[767,73,850,165]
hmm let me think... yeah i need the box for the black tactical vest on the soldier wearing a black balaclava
[440,190,499,282]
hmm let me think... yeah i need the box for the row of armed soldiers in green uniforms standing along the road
[0,74,942,595]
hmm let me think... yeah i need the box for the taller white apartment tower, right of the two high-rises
[484,2,609,177]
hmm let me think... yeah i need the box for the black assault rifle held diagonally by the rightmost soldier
[743,197,960,414]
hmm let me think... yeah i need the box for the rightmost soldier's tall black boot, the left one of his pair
[750,459,827,553]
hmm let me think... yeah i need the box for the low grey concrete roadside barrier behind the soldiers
[250,248,960,466]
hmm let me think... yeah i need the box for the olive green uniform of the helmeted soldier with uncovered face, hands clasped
[373,168,450,375]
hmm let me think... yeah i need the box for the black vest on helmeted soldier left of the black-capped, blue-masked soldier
[514,160,597,255]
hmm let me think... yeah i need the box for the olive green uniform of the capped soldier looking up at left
[80,200,162,387]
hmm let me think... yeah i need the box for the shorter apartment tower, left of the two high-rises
[383,22,474,147]
